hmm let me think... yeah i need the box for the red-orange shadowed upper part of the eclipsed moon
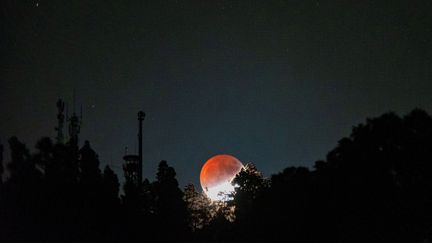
[200,154,243,194]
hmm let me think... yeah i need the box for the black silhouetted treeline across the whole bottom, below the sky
[0,109,432,242]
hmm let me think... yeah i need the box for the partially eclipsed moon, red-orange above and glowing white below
[200,154,243,201]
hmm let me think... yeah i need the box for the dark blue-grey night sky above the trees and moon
[0,0,432,185]
